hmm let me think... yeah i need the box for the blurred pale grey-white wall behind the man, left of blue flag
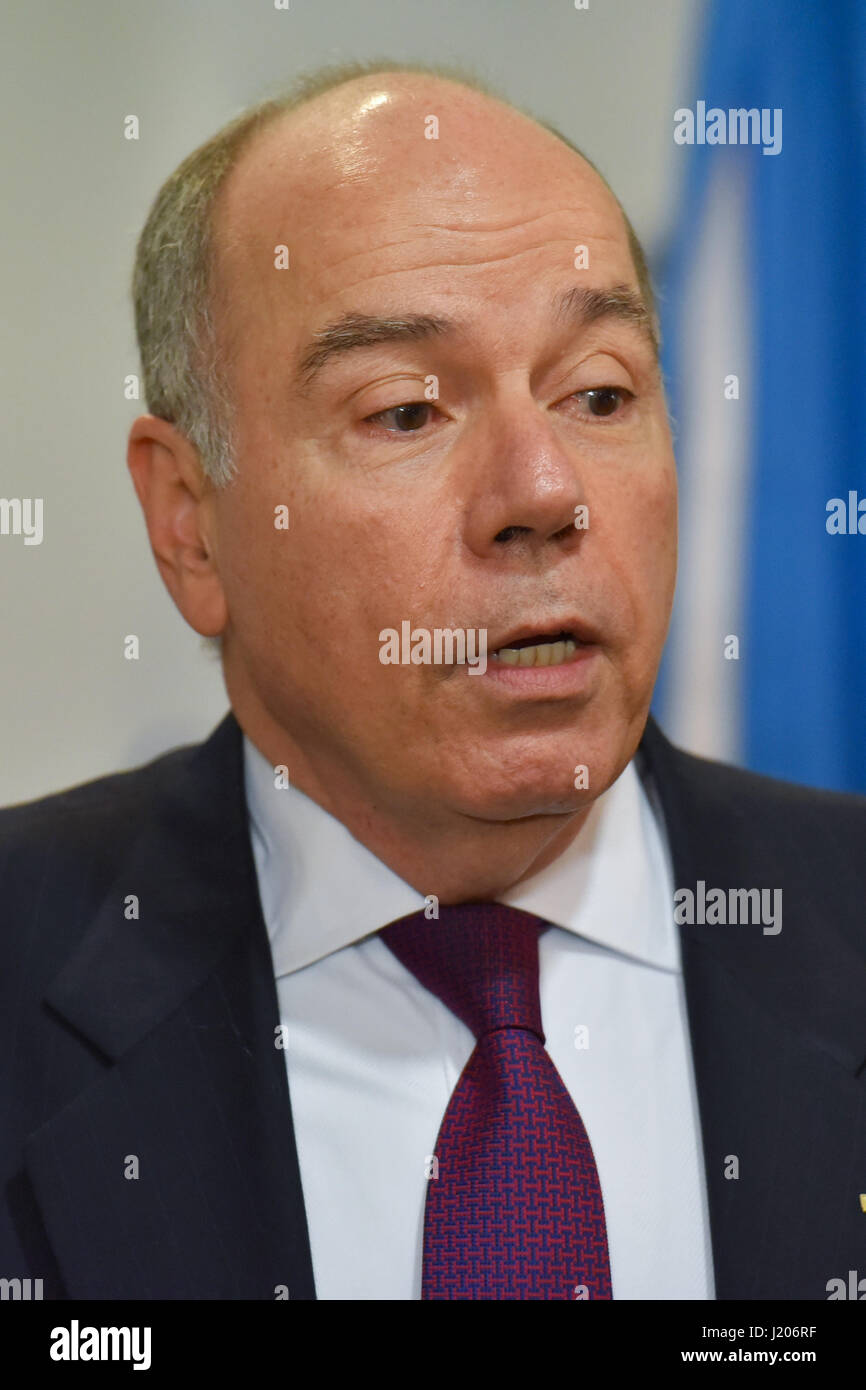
[0,0,702,803]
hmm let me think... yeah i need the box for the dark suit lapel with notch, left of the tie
[25,714,316,1298]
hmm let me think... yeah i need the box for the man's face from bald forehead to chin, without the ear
[208,76,676,820]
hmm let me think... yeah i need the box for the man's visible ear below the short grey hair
[126,416,228,637]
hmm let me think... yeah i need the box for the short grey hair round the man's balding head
[132,60,657,487]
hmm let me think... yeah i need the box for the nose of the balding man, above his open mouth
[460,392,588,555]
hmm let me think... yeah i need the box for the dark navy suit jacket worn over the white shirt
[0,714,866,1300]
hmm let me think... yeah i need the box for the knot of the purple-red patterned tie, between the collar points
[379,902,548,1043]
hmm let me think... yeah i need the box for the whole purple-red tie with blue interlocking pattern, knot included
[381,902,613,1300]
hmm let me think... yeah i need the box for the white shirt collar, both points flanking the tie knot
[243,737,678,976]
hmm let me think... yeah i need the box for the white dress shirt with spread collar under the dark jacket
[245,738,714,1300]
